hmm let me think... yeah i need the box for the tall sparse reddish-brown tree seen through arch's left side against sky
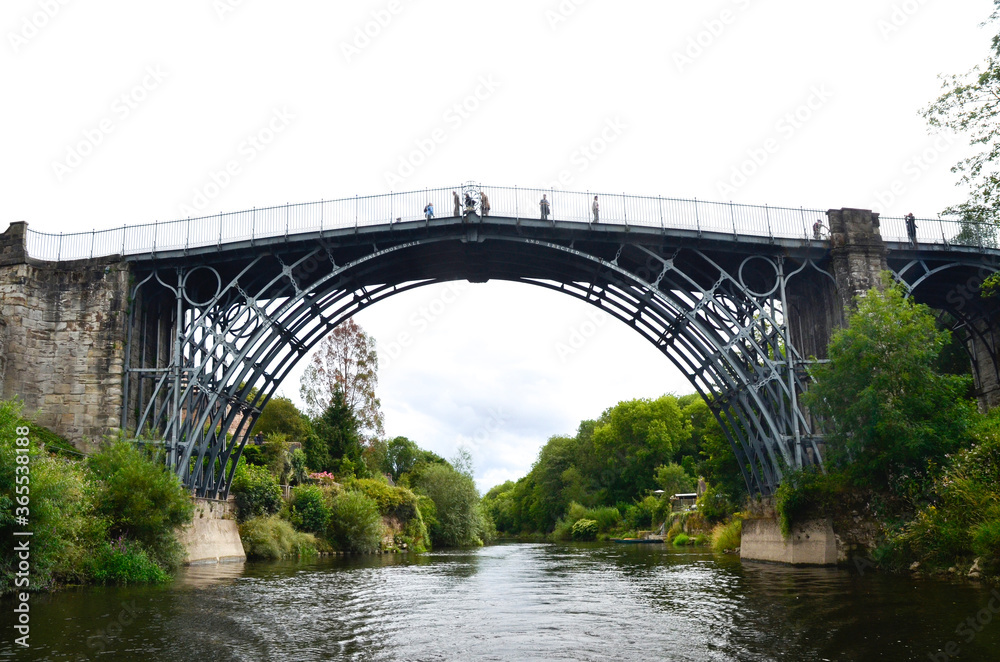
[299,319,385,441]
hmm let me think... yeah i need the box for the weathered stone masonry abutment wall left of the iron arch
[0,223,129,448]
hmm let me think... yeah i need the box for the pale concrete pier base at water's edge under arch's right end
[740,519,837,565]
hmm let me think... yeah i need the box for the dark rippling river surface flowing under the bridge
[0,543,1000,662]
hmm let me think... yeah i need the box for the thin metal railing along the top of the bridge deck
[19,185,997,261]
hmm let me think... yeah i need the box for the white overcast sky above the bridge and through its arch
[0,0,996,489]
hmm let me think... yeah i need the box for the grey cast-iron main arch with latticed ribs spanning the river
[123,226,821,497]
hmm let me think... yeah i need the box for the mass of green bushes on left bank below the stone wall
[0,401,191,594]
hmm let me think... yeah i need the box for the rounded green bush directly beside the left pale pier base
[87,439,194,568]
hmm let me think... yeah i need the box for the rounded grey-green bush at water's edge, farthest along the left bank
[414,464,490,547]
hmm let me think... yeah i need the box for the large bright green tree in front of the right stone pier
[805,275,972,485]
